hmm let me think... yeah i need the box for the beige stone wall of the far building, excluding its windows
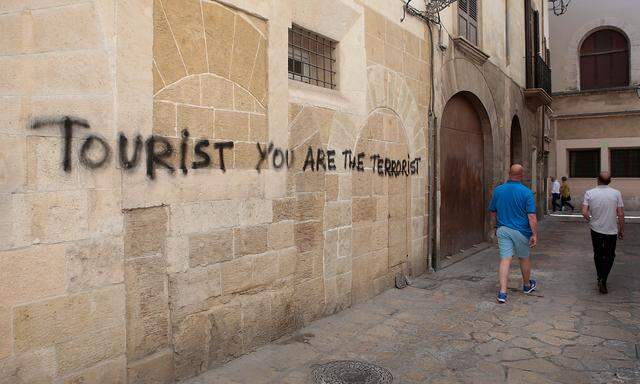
[549,0,640,211]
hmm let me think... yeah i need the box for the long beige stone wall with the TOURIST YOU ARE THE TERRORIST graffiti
[0,0,429,384]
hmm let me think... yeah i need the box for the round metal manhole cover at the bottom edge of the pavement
[312,360,393,384]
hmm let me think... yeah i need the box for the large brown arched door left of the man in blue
[439,92,492,257]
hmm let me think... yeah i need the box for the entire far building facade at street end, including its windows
[550,0,640,210]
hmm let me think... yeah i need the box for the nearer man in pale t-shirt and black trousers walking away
[582,171,624,294]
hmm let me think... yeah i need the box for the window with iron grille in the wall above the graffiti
[289,24,336,89]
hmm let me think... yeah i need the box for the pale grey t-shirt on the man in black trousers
[582,185,624,235]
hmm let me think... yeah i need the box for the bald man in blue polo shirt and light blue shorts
[489,164,538,303]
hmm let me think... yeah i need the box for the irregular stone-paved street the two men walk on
[182,219,640,384]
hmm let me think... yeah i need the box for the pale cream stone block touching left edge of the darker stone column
[65,238,124,292]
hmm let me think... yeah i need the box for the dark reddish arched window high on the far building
[580,29,629,89]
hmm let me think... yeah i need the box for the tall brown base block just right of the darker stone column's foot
[173,312,211,380]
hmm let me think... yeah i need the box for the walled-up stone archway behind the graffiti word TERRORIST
[351,108,411,303]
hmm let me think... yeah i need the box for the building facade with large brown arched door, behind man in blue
[431,0,551,265]
